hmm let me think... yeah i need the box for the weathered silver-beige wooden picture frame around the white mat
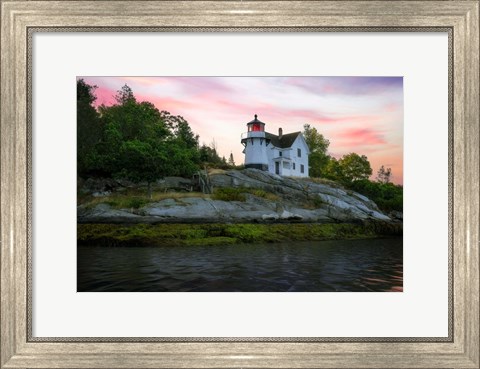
[0,0,480,369]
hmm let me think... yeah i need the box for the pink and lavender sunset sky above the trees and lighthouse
[78,77,403,184]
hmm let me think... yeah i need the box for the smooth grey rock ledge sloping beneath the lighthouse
[77,169,399,223]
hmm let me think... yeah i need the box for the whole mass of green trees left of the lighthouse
[77,79,235,191]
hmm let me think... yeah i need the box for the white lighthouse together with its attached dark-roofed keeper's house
[241,114,310,177]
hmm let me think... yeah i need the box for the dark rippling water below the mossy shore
[77,238,403,292]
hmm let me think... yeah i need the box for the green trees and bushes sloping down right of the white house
[303,124,403,211]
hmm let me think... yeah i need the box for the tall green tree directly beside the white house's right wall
[303,124,331,177]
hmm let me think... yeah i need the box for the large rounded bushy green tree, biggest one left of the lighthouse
[97,85,199,196]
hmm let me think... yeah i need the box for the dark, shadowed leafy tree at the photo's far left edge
[77,79,104,175]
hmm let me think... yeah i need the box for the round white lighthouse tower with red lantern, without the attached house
[242,114,270,171]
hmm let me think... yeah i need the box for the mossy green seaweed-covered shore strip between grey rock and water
[77,221,403,247]
